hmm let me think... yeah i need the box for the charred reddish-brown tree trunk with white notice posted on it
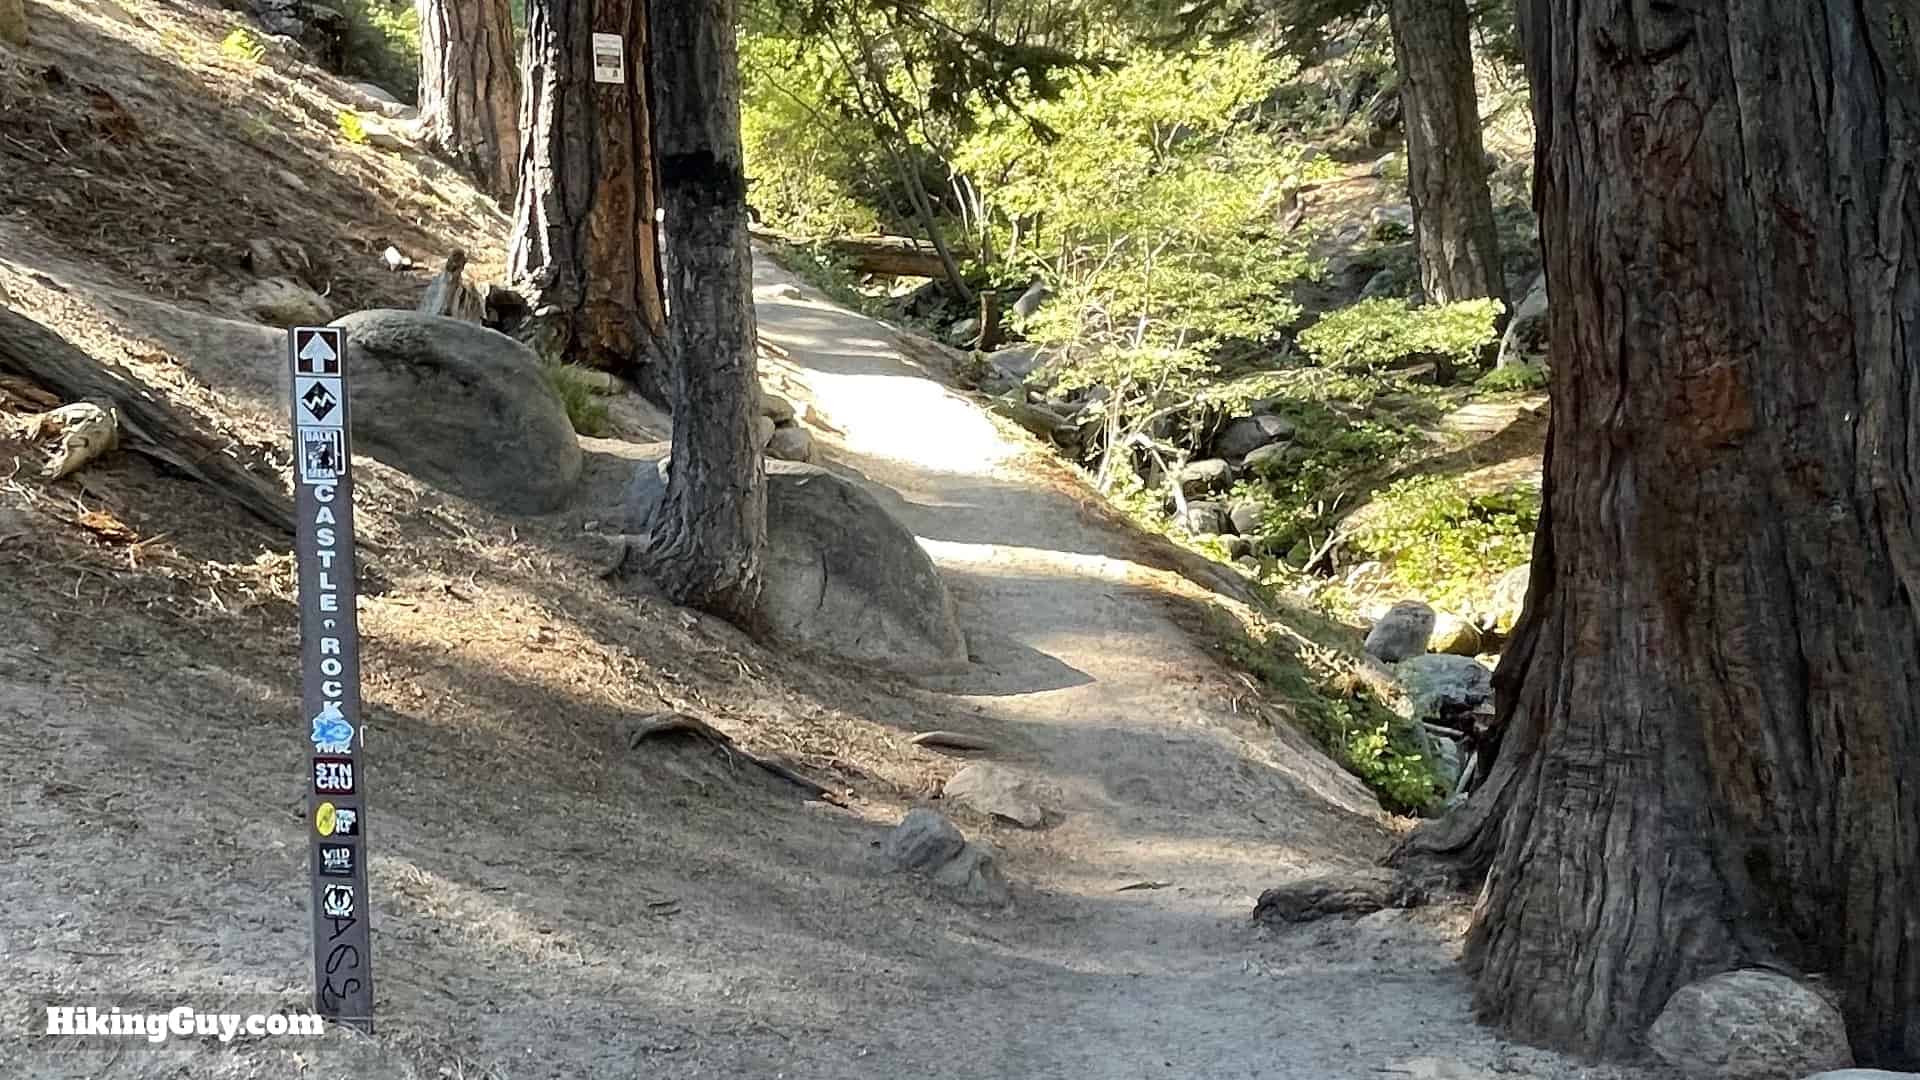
[507,0,666,382]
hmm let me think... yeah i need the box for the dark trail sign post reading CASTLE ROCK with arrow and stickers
[288,327,372,1030]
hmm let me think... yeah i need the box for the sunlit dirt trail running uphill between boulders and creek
[755,259,1658,1080]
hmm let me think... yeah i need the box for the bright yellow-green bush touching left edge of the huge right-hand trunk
[1354,477,1540,607]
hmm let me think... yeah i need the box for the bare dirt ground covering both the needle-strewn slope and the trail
[0,0,1655,1080]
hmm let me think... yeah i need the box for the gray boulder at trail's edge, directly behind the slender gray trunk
[626,459,966,673]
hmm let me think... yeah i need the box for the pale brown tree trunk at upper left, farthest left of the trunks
[415,0,520,198]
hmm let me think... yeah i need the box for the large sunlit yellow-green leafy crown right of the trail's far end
[954,44,1323,352]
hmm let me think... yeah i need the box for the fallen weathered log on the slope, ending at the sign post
[0,307,294,534]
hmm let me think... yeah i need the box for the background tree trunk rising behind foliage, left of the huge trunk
[1390,0,1507,304]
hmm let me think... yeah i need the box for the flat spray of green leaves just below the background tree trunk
[1300,300,1505,367]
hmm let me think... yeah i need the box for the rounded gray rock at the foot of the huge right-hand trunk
[1647,969,1853,1080]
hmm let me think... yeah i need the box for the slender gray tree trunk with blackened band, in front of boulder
[647,0,766,626]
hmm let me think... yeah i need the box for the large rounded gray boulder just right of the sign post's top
[334,311,580,513]
